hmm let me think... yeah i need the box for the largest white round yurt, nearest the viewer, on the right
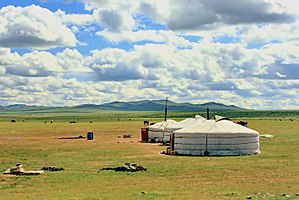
[170,119,260,156]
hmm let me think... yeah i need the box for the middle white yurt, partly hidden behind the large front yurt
[163,115,206,142]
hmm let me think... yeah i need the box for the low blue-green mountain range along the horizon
[0,100,243,111]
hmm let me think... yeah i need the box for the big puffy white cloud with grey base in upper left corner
[0,5,77,49]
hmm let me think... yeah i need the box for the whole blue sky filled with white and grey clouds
[0,0,299,109]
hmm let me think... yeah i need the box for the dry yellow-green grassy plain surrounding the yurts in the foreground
[0,112,299,200]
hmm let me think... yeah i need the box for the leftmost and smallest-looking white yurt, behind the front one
[148,119,177,142]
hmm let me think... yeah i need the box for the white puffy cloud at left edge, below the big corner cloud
[0,48,91,78]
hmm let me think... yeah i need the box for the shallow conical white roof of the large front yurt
[175,120,259,135]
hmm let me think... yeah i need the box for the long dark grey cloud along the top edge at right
[141,0,294,30]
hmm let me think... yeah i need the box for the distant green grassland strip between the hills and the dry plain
[0,107,299,122]
